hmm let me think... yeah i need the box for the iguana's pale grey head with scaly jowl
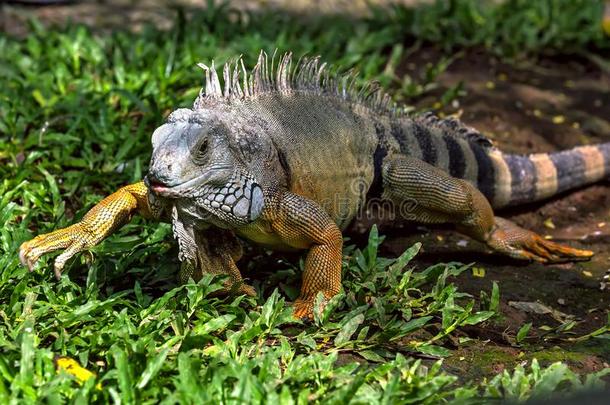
[145,109,263,227]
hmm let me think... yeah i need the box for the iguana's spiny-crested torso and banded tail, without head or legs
[207,53,610,228]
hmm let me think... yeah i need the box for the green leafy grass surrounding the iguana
[0,0,610,403]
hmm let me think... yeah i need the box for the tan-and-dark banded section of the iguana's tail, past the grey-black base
[486,143,610,208]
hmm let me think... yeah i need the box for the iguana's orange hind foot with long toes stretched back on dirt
[487,217,593,263]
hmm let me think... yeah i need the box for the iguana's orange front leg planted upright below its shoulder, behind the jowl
[270,193,343,319]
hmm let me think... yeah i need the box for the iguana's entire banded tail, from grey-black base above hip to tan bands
[386,113,610,208]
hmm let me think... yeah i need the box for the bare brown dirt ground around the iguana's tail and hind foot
[0,0,610,377]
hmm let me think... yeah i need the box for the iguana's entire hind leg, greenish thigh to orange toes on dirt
[383,156,593,263]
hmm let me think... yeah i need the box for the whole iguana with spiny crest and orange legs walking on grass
[20,49,610,317]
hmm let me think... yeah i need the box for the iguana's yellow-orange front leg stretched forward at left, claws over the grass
[19,181,157,278]
